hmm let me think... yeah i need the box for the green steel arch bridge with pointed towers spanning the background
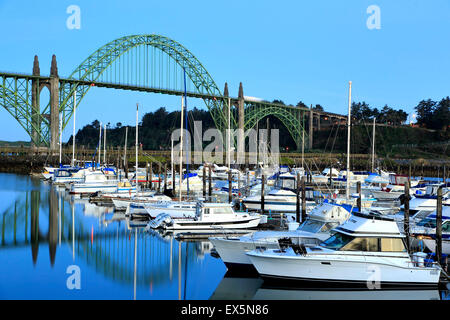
[0,34,339,148]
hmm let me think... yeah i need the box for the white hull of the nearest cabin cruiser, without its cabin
[248,251,440,289]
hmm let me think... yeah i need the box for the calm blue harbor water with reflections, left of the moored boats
[0,173,450,300]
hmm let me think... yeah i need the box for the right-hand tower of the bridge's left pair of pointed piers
[50,55,59,153]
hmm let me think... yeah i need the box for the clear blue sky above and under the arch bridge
[0,0,450,141]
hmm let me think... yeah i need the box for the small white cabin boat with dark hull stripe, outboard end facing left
[149,203,262,231]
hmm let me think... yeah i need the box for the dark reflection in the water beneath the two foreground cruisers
[209,272,450,300]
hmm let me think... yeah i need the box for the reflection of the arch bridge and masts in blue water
[0,175,218,299]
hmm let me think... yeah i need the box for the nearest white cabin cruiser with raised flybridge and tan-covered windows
[247,213,441,288]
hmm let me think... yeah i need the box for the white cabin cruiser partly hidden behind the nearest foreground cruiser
[209,201,353,271]
